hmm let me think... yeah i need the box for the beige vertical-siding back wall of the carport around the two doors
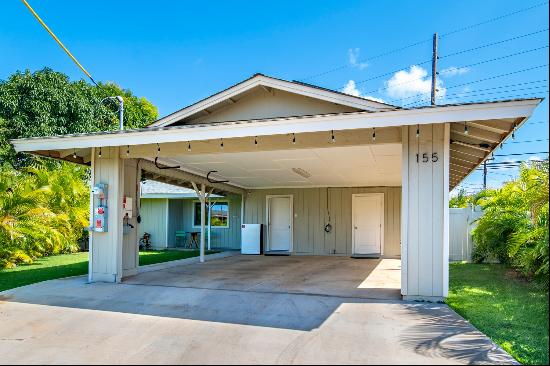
[244,187,401,256]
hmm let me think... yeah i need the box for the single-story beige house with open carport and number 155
[9,74,541,300]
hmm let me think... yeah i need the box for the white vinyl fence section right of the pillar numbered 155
[449,207,483,262]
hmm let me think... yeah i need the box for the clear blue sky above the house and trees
[0,0,549,190]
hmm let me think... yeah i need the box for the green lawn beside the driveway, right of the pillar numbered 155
[446,263,548,364]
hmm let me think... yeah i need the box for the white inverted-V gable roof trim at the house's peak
[150,74,398,127]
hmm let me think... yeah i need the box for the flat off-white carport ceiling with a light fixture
[157,144,402,189]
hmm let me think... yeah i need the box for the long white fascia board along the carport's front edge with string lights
[12,99,540,152]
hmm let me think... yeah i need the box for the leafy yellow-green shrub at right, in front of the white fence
[472,161,549,284]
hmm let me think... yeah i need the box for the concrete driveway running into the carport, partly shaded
[0,256,515,364]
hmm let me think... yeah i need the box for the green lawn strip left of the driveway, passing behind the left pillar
[0,250,220,291]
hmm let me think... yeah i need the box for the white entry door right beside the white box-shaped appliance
[267,196,292,251]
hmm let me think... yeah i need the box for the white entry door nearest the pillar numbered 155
[352,193,384,254]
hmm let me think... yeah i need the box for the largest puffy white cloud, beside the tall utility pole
[386,65,447,98]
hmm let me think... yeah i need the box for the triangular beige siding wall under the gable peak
[186,88,358,124]
